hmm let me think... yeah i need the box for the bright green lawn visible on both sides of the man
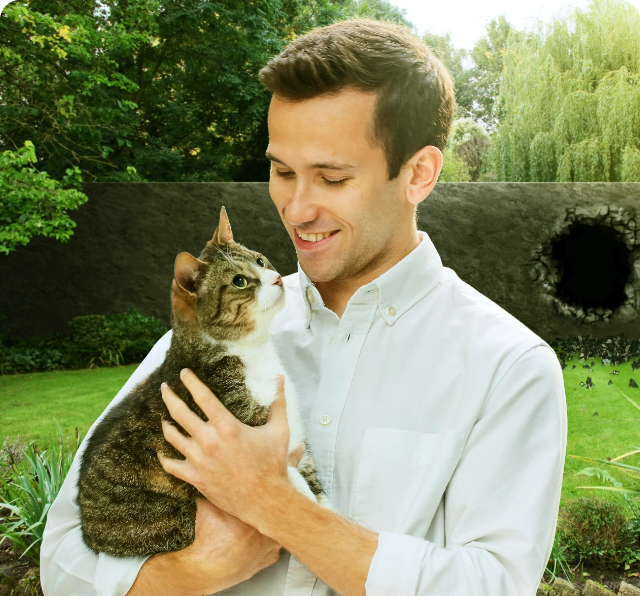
[0,358,640,510]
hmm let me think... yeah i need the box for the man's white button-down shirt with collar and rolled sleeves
[41,232,567,596]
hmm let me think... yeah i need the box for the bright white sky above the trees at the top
[391,0,589,49]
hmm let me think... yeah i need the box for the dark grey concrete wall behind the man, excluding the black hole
[0,183,640,340]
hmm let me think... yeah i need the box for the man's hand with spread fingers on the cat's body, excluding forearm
[158,369,292,526]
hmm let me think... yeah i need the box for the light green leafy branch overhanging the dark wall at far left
[0,141,87,254]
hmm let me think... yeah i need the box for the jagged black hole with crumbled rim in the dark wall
[530,206,640,324]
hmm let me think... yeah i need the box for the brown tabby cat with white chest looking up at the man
[78,207,326,557]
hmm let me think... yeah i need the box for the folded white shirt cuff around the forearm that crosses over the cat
[365,532,429,596]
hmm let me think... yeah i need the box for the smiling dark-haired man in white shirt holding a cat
[42,20,566,596]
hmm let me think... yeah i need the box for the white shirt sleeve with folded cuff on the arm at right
[366,345,567,596]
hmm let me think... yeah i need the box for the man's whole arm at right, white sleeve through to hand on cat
[161,346,567,596]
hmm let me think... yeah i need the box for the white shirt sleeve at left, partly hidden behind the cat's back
[40,331,171,596]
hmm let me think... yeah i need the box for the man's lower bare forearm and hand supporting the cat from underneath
[127,499,281,596]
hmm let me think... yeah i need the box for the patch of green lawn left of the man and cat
[0,364,139,450]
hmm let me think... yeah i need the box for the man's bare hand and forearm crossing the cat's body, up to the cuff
[158,371,378,596]
